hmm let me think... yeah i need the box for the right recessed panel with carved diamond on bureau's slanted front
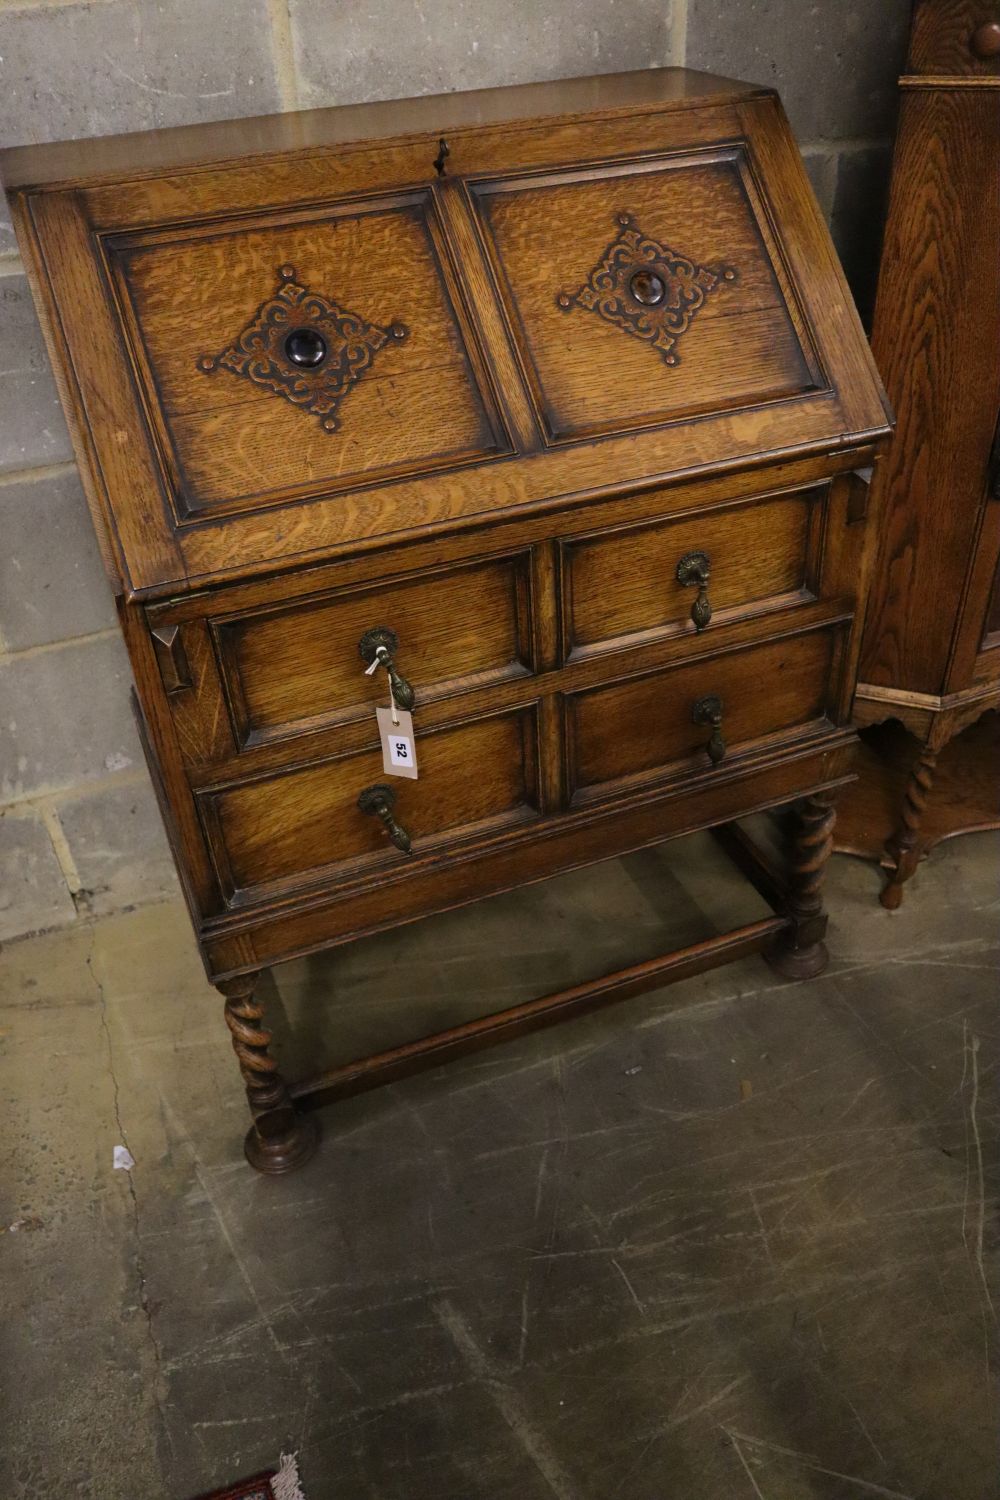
[475,147,823,443]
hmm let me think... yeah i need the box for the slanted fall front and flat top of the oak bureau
[0,69,886,594]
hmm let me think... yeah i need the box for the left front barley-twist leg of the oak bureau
[216,974,319,1173]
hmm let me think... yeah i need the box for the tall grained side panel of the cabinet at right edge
[861,90,1000,693]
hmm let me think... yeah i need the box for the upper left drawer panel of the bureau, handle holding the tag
[213,552,531,746]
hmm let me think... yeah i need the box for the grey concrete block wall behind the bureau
[0,0,909,938]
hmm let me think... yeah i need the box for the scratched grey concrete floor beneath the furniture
[0,834,1000,1500]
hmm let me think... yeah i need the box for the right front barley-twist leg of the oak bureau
[766,792,837,980]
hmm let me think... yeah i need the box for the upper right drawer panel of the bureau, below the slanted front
[562,486,826,654]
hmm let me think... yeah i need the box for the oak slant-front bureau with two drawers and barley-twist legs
[0,69,888,1172]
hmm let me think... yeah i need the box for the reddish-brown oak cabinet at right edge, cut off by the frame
[838,0,1000,909]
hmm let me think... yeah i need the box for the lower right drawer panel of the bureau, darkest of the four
[567,626,843,801]
